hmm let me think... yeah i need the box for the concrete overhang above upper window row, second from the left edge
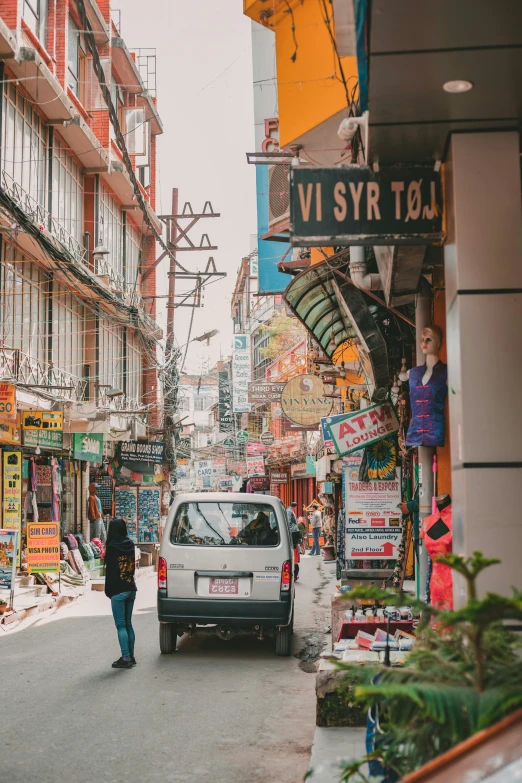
[7,46,76,122]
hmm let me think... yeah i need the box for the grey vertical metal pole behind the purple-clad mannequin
[415,276,435,598]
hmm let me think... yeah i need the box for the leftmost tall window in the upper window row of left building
[1,81,47,208]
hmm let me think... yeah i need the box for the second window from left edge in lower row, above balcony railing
[52,285,85,378]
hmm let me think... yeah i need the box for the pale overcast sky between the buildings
[121,0,256,372]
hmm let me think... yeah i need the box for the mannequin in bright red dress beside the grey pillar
[421,494,453,609]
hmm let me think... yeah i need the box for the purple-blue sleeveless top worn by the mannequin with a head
[406,360,448,446]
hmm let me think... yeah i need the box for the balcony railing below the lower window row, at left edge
[0,347,89,401]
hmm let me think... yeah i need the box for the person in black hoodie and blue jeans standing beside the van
[105,517,137,669]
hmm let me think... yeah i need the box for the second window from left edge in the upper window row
[52,133,83,244]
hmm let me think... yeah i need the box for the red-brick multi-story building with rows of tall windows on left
[0,0,162,544]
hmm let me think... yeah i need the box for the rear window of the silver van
[170,501,280,546]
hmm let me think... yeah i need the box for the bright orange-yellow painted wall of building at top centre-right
[244,0,357,147]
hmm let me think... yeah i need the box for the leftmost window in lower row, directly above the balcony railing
[0,244,48,366]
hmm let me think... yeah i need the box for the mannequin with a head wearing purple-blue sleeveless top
[406,325,448,446]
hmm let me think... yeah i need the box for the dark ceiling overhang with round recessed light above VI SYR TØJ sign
[357,0,522,164]
